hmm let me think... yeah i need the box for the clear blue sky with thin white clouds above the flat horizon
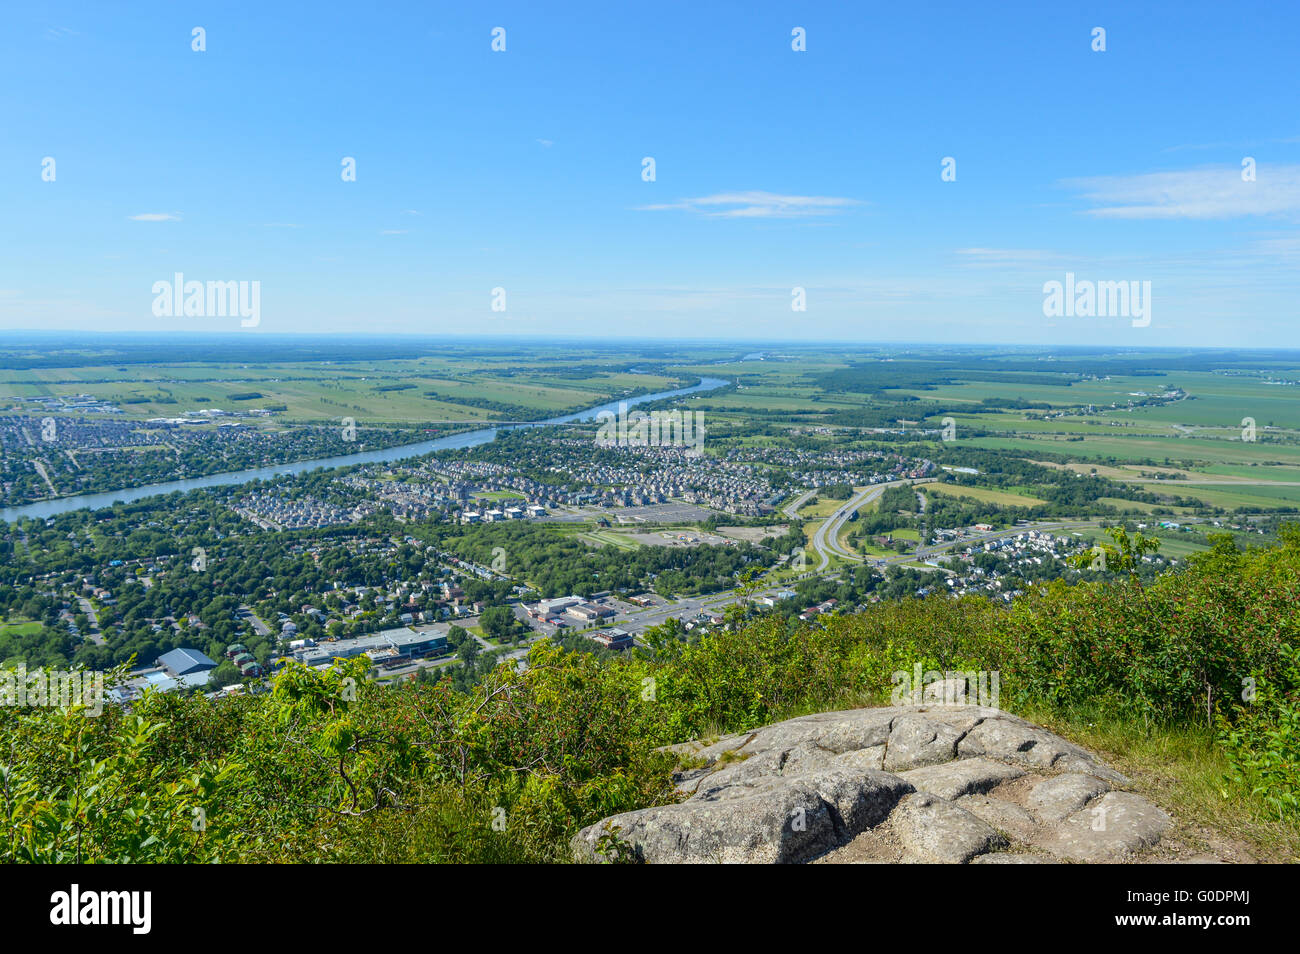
[0,0,1300,347]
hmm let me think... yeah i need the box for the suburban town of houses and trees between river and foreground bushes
[12,418,1190,699]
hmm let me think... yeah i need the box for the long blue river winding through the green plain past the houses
[0,377,729,524]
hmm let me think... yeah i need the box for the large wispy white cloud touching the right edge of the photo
[1061,164,1300,218]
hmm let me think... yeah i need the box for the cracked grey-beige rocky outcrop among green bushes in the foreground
[573,704,1171,864]
